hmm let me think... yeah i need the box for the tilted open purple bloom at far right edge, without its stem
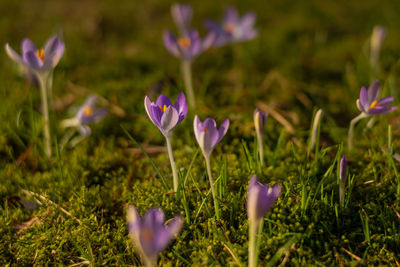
[357,81,397,116]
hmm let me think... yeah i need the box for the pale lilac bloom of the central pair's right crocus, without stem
[193,115,229,158]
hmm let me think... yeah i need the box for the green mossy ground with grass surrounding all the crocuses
[0,0,400,266]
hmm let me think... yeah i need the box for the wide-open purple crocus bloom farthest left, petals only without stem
[6,35,65,73]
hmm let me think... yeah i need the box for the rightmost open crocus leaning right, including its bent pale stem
[348,81,397,150]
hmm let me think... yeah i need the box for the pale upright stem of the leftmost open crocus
[37,74,51,158]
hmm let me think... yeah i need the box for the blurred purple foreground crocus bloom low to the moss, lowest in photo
[127,206,183,266]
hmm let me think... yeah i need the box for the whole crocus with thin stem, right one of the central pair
[193,115,229,219]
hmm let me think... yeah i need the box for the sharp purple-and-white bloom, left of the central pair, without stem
[144,93,188,137]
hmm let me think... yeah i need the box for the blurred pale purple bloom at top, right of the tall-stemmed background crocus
[205,6,258,46]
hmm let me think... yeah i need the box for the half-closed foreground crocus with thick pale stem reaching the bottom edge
[247,175,281,267]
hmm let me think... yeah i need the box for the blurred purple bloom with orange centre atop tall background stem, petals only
[163,29,215,62]
